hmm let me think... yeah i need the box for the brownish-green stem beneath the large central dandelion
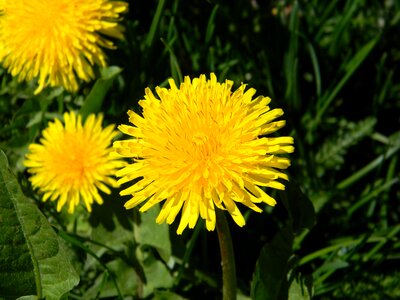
[216,209,236,300]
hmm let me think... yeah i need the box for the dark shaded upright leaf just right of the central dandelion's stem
[251,226,293,300]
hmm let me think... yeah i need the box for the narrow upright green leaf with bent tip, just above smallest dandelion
[80,66,122,119]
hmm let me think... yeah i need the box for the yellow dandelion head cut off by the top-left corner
[0,0,128,94]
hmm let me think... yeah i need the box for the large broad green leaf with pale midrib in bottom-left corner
[0,150,79,300]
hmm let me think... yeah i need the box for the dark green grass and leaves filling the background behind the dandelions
[0,0,400,299]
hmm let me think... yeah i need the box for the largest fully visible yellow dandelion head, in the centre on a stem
[114,74,294,234]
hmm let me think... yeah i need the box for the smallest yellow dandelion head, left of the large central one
[24,112,122,213]
